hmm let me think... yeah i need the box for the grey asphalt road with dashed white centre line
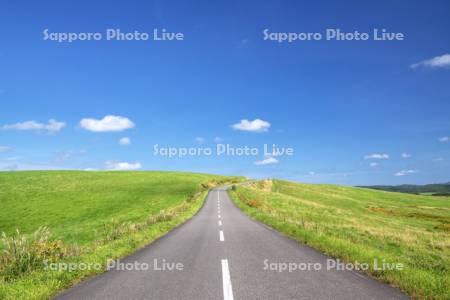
[57,189,407,300]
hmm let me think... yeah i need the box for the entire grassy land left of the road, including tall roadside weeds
[0,171,239,299]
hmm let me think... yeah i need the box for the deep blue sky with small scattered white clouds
[0,1,450,185]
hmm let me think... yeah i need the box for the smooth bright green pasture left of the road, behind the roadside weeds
[0,171,229,245]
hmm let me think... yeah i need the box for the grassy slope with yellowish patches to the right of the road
[230,180,450,299]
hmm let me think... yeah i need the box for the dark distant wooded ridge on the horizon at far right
[359,182,450,196]
